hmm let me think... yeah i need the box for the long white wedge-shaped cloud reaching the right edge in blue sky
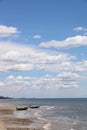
[39,35,87,48]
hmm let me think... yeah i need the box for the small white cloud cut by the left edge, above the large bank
[0,25,19,37]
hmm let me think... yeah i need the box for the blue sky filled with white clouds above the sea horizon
[0,0,87,98]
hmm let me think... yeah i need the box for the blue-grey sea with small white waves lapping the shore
[0,98,87,130]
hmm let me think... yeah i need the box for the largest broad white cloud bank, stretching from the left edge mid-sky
[0,42,74,72]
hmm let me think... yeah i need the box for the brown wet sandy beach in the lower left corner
[0,106,43,130]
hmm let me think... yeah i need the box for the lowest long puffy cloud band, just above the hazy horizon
[0,72,79,91]
